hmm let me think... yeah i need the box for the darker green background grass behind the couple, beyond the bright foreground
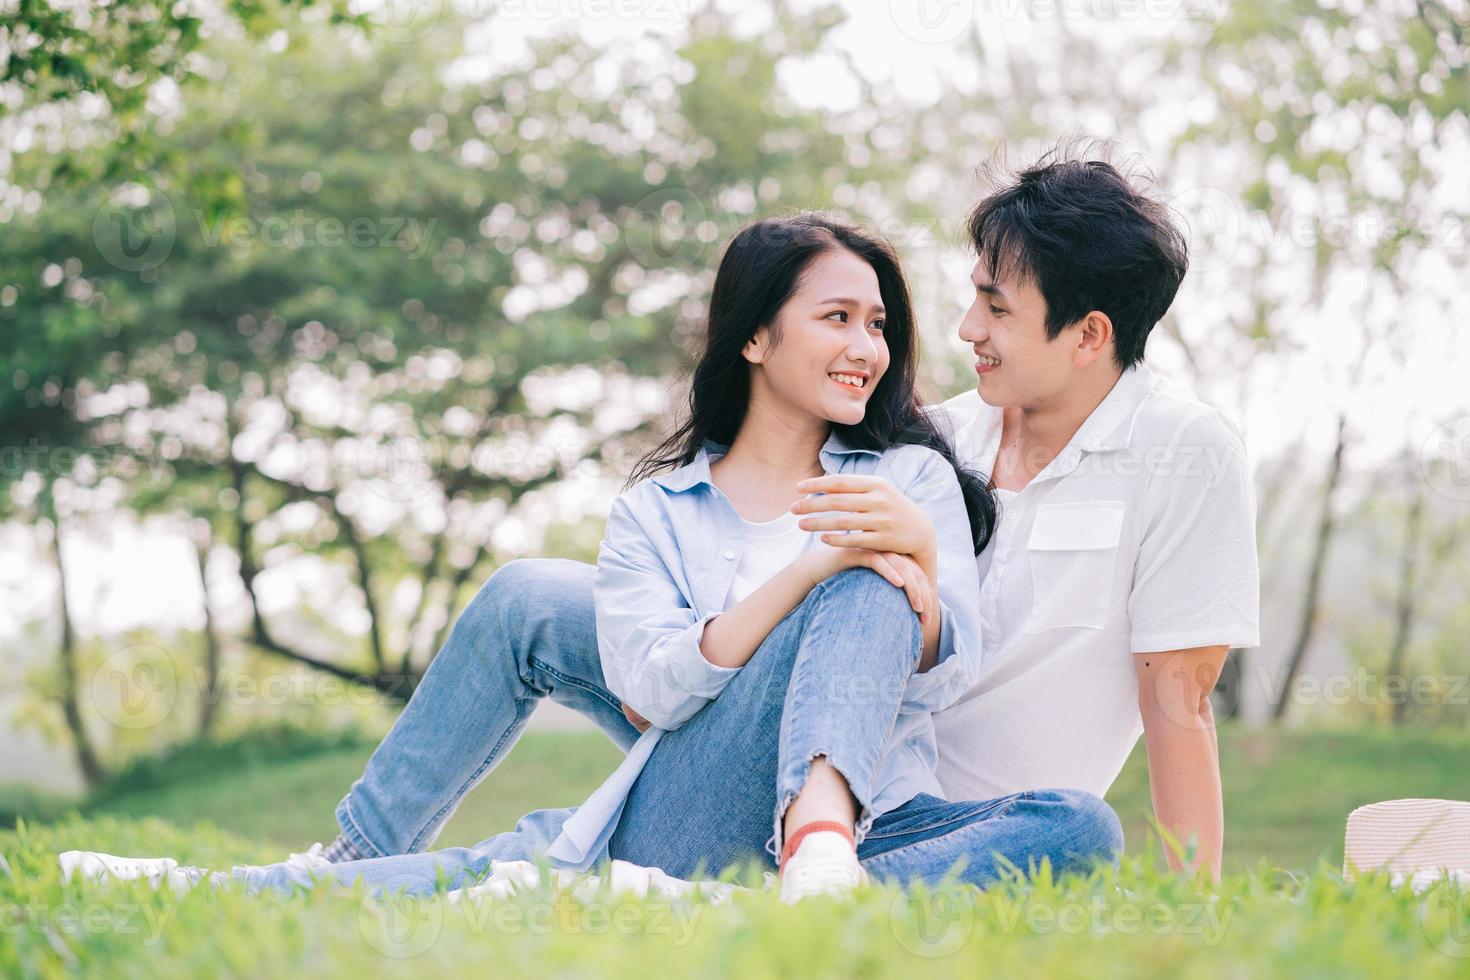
[53,727,1470,870]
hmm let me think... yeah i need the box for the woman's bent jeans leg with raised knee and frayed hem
[610,569,920,877]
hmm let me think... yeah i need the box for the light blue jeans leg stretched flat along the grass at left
[232,808,572,895]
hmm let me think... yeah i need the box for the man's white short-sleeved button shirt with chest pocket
[935,366,1260,799]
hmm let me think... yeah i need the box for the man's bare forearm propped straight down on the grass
[1133,646,1230,880]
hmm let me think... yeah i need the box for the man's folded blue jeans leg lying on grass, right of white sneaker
[857,789,1123,887]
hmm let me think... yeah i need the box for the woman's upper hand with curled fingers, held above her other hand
[791,475,938,569]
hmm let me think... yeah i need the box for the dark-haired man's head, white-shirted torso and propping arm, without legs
[936,162,1260,876]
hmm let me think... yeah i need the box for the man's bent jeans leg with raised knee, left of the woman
[329,560,638,860]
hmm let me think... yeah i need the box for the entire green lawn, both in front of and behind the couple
[0,730,1470,979]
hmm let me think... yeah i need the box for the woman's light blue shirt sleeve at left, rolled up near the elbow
[592,488,739,730]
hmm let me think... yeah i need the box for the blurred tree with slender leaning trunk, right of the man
[1176,0,1470,720]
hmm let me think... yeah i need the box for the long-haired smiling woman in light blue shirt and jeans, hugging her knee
[66,213,995,901]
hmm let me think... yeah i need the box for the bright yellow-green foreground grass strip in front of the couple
[0,817,1470,980]
